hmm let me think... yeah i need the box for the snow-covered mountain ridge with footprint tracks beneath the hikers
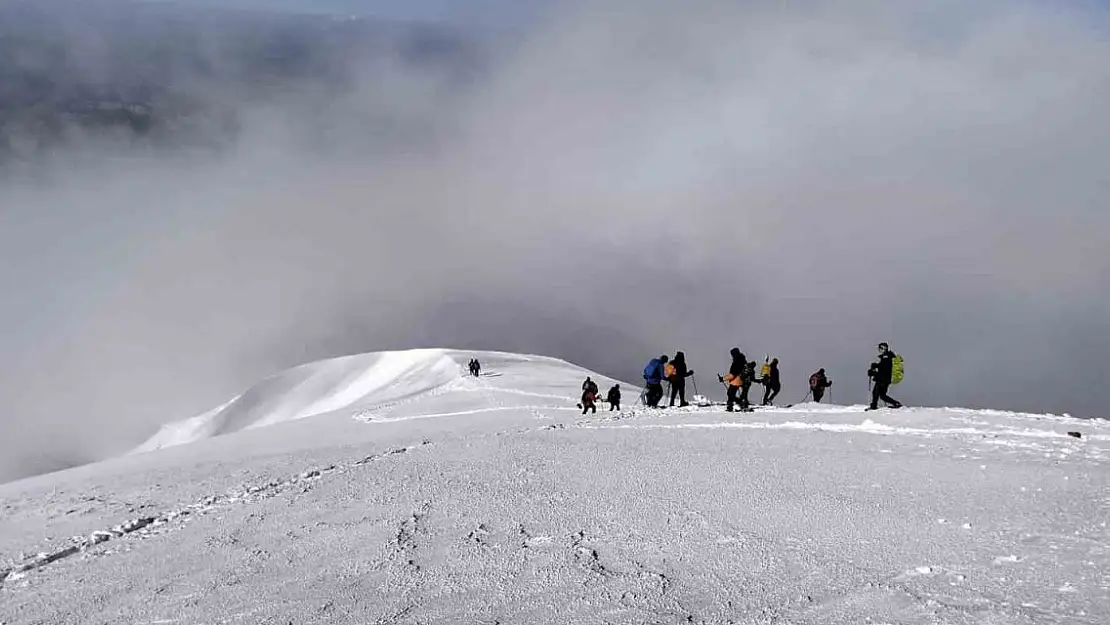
[0,350,1110,625]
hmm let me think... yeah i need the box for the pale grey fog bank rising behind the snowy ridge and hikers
[0,0,1110,480]
